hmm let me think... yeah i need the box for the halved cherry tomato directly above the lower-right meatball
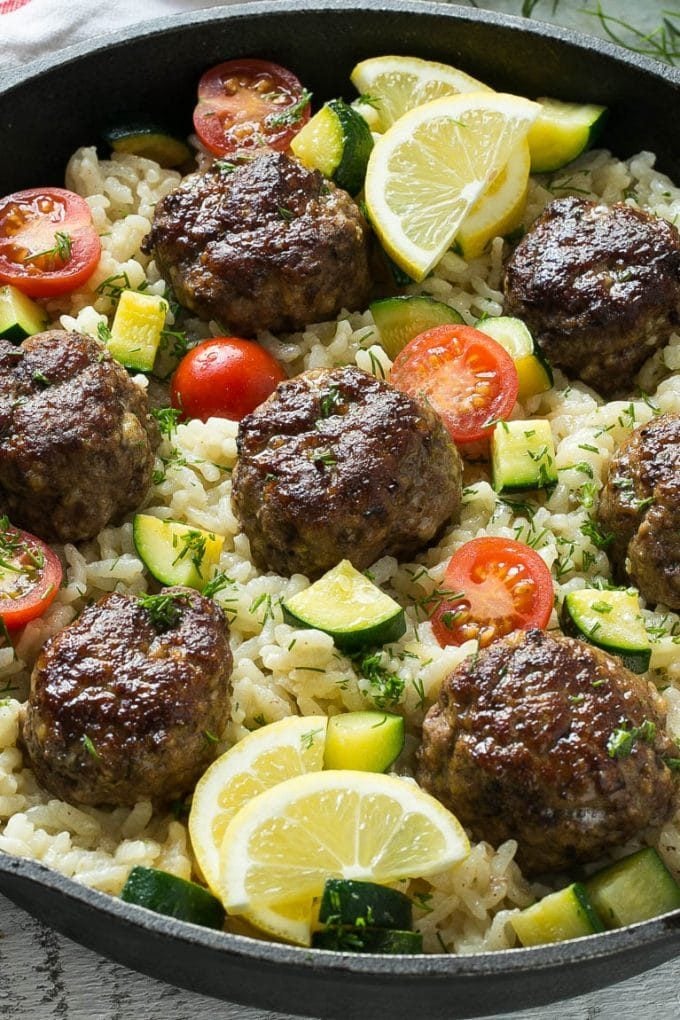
[431,537,554,648]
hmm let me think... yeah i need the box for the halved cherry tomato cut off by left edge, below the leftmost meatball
[0,517,63,630]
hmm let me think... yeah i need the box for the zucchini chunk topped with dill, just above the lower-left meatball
[133,513,224,592]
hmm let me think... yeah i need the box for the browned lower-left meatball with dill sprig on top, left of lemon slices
[23,588,231,805]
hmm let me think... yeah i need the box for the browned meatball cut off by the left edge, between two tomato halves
[0,329,158,542]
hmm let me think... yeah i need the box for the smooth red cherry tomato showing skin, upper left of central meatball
[170,337,286,421]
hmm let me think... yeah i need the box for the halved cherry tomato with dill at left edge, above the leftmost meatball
[0,188,102,298]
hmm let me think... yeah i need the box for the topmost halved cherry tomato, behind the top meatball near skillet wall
[194,60,311,156]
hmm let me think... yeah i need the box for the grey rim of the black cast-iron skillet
[0,0,680,995]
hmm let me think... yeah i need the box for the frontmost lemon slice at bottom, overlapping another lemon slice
[220,770,470,913]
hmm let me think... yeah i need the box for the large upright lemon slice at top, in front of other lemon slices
[366,92,540,281]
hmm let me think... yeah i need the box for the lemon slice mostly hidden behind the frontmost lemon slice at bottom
[189,715,328,945]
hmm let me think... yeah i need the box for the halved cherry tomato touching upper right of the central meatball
[389,325,519,443]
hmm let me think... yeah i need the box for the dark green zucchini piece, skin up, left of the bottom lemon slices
[120,866,224,928]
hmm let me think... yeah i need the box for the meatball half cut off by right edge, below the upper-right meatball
[597,414,680,609]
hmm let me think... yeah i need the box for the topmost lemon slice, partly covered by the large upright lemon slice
[350,56,491,132]
